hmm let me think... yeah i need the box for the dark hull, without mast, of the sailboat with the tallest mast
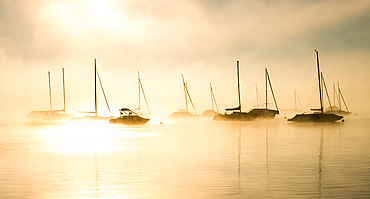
[288,113,343,122]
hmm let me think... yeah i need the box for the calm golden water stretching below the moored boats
[0,118,370,198]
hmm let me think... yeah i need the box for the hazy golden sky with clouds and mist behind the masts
[0,0,370,120]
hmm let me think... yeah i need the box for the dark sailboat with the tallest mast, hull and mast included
[288,50,343,122]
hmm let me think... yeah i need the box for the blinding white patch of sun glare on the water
[40,122,153,154]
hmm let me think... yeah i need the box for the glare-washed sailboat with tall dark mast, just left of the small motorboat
[70,59,113,121]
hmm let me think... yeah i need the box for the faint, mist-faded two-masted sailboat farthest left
[26,68,74,120]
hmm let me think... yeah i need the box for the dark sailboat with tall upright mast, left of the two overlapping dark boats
[213,61,258,121]
